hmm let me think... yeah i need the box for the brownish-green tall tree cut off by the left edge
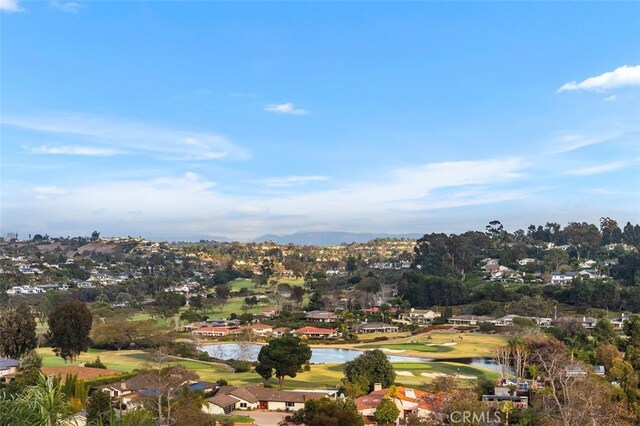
[0,305,37,359]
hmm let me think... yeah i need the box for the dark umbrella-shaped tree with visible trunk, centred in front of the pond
[256,335,311,390]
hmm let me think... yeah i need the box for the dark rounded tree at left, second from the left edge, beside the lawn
[48,300,93,362]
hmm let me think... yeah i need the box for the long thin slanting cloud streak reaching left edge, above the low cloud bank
[0,113,249,160]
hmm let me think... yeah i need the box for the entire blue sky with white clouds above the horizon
[0,0,640,239]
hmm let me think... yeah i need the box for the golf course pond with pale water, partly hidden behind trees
[200,343,499,371]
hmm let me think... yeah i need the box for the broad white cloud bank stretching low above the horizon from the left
[4,158,530,241]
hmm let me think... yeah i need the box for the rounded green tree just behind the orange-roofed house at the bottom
[344,349,396,392]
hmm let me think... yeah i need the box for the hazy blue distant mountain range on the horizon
[254,231,422,246]
